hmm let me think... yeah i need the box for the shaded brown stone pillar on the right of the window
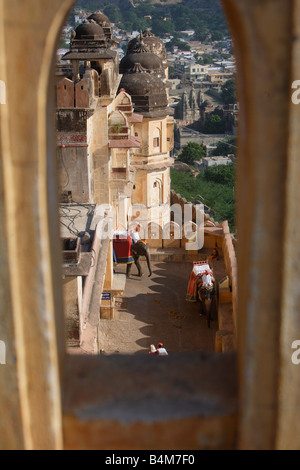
[223,0,300,449]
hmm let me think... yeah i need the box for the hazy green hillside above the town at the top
[72,0,228,41]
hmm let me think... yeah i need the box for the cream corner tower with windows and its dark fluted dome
[119,63,174,226]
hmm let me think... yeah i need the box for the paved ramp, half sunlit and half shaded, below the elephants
[100,262,217,354]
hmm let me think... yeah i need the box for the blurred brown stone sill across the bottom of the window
[63,352,237,450]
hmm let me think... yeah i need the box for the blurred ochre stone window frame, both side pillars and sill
[0,0,300,449]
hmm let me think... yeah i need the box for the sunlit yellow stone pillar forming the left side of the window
[0,0,73,450]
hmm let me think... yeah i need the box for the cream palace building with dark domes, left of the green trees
[56,11,174,340]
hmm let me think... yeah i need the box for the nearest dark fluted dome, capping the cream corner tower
[119,63,168,114]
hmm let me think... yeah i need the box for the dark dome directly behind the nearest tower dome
[119,42,164,78]
